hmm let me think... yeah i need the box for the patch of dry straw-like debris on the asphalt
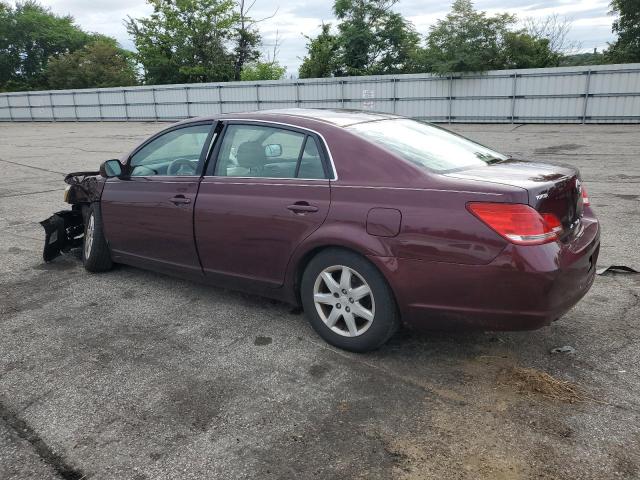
[498,367,587,403]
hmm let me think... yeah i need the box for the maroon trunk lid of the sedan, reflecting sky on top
[446,159,584,237]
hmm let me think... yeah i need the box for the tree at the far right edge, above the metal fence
[605,0,640,63]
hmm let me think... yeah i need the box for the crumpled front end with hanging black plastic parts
[40,172,104,262]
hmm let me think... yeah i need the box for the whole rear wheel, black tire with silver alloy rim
[300,248,400,352]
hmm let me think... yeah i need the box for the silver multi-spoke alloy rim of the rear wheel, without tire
[313,265,375,337]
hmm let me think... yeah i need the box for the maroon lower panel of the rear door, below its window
[194,177,330,287]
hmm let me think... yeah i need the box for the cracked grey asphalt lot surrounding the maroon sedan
[0,123,640,480]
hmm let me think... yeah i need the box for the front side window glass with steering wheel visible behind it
[129,125,212,177]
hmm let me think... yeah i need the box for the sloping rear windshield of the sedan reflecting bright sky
[347,119,508,172]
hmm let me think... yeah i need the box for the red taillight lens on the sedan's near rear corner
[467,202,562,245]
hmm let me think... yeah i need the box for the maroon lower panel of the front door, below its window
[101,176,200,270]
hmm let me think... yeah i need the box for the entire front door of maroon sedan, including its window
[96,122,215,275]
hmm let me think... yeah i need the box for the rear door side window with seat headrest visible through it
[214,125,325,179]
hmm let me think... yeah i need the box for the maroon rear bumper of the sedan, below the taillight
[371,217,600,330]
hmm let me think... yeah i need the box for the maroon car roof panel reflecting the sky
[186,108,404,127]
